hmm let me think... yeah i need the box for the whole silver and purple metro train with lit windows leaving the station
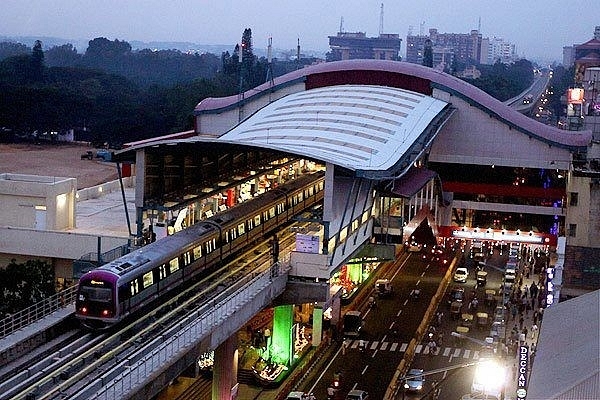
[75,172,324,330]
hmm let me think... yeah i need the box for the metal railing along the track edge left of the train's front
[0,285,77,339]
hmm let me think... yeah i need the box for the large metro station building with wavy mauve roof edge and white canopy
[116,60,600,306]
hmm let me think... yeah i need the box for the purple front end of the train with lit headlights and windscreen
[75,270,121,330]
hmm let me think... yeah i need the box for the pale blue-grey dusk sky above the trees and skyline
[0,0,600,61]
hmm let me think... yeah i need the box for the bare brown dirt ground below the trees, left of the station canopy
[0,143,118,189]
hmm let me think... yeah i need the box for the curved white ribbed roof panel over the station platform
[216,85,448,177]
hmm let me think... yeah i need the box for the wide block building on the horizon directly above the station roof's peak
[327,32,402,61]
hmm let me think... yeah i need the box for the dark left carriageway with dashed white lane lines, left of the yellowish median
[303,248,448,399]
